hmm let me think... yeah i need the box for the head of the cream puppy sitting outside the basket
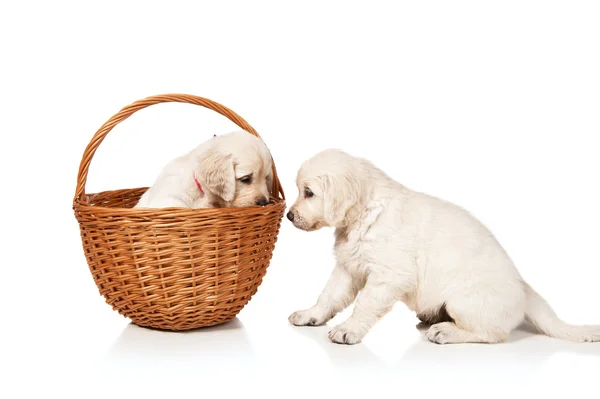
[287,149,361,231]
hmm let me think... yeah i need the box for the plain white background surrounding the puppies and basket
[0,0,600,398]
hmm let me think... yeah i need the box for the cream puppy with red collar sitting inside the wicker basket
[135,131,273,208]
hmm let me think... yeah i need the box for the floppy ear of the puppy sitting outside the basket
[323,175,360,227]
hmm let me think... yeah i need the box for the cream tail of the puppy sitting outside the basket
[525,283,600,342]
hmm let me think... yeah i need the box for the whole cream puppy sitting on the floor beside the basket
[287,150,600,344]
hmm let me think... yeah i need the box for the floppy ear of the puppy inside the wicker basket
[198,149,235,202]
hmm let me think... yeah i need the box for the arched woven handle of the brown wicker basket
[73,94,285,201]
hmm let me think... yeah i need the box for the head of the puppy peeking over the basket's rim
[196,131,273,207]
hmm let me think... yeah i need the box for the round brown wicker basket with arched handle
[73,94,285,331]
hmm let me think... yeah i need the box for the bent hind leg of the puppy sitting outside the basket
[425,293,524,344]
